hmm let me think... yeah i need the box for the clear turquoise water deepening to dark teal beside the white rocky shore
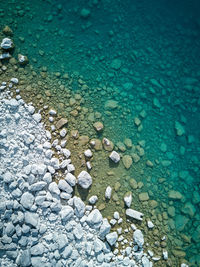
[0,0,200,266]
